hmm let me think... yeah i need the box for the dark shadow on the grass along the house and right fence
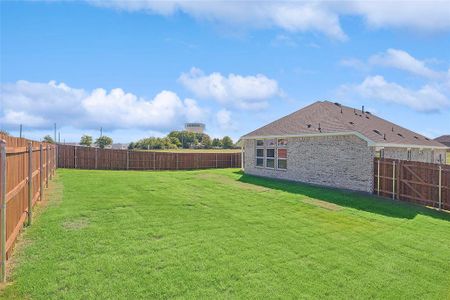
[234,171,450,222]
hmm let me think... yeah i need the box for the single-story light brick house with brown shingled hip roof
[241,101,447,192]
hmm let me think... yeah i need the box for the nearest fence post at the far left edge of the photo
[0,140,6,282]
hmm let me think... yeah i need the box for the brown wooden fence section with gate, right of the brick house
[374,158,450,210]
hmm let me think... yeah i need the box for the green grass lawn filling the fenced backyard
[2,169,450,299]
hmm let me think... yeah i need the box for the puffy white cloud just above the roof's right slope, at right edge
[341,75,450,112]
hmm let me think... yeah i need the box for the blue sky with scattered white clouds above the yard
[0,0,450,143]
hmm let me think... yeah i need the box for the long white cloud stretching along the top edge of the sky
[87,0,450,40]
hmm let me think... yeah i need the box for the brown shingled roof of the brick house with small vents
[242,101,446,148]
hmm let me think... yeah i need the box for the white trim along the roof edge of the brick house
[241,131,450,150]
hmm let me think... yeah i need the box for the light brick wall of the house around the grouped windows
[244,135,375,192]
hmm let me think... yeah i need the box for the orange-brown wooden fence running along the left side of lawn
[0,134,56,282]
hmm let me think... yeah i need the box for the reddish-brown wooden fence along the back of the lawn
[58,145,241,170]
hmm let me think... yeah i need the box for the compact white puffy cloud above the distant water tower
[179,68,281,109]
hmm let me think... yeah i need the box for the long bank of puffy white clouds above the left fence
[0,81,203,130]
